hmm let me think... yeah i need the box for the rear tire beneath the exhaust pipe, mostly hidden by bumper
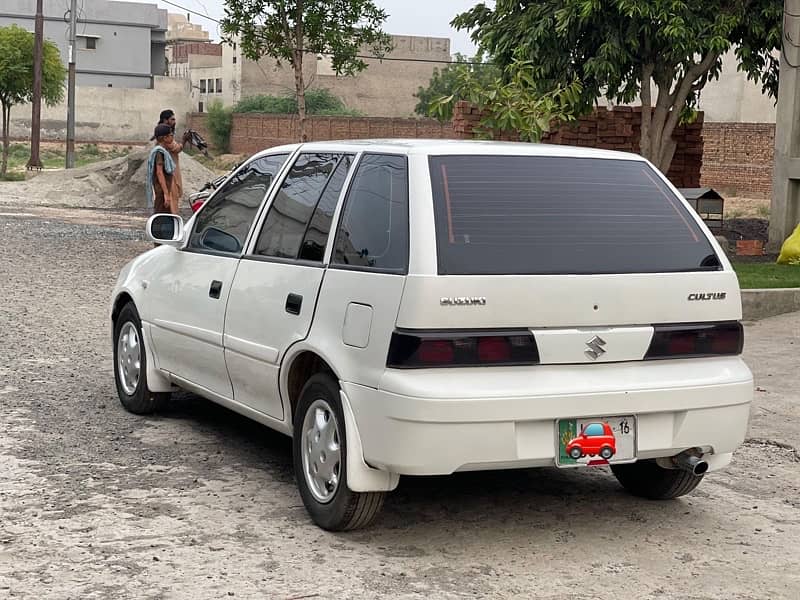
[611,460,703,500]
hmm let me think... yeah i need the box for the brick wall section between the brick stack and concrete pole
[700,123,775,198]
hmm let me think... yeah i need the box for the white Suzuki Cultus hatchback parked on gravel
[111,140,753,530]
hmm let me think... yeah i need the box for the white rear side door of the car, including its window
[224,152,353,419]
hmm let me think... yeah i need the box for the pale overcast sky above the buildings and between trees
[156,0,484,56]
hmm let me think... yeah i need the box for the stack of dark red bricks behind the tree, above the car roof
[453,102,704,187]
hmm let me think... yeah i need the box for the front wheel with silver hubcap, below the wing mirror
[114,302,170,415]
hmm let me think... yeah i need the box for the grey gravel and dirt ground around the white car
[0,204,800,599]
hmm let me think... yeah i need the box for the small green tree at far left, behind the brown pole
[0,25,66,177]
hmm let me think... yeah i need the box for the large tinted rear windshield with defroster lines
[430,156,720,275]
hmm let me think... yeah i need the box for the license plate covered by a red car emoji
[556,415,636,467]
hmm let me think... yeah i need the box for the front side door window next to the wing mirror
[186,154,288,254]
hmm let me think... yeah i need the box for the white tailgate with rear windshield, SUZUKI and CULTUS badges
[397,155,741,364]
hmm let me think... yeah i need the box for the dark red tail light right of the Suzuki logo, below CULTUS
[644,321,744,360]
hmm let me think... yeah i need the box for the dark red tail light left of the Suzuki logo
[386,329,539,369]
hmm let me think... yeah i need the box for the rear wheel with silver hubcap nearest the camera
[292,373,386,531]
